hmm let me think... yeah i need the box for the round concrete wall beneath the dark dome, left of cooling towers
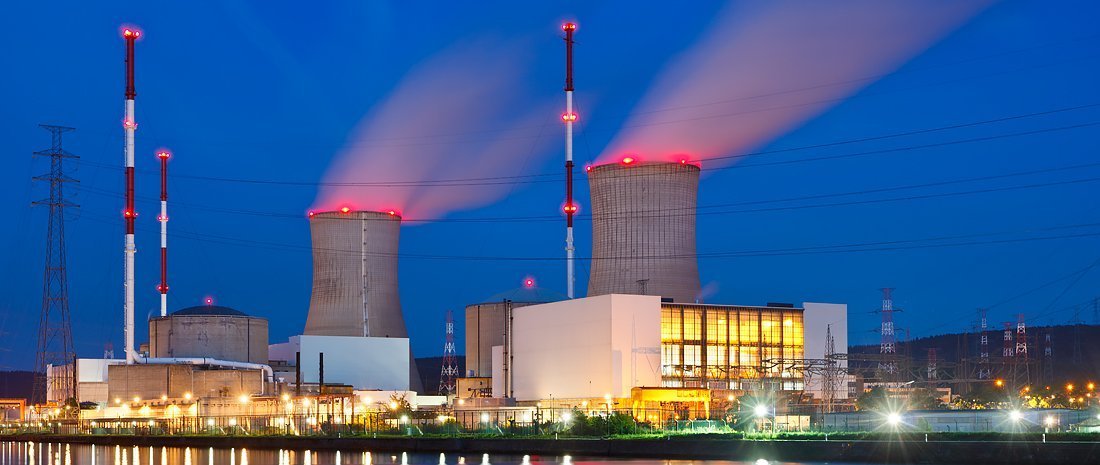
[149,315,267,364]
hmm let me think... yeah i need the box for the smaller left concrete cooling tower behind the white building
[305,209,420,386]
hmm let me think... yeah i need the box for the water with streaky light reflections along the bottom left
[0,442,880,465]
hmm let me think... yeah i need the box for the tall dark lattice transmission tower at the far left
[31,124,77,403]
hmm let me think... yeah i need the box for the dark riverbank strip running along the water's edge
[0,434,1100,464]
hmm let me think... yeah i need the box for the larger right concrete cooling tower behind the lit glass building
[589,158,700,302]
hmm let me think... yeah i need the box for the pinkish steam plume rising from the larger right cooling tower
[600,0,989,163]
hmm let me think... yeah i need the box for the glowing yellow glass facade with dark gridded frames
[661,303,804,390]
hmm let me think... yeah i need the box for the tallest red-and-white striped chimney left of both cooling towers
[122,29,141,365]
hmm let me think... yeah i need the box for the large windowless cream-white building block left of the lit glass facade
[506,295,661,400]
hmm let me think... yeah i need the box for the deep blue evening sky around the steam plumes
[0,1,1100,368]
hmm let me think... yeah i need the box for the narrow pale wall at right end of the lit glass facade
[803,302,848,400]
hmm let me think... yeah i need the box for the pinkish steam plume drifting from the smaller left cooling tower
[314,42,554,220]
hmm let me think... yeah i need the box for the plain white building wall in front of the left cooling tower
[297,335,410,390]
